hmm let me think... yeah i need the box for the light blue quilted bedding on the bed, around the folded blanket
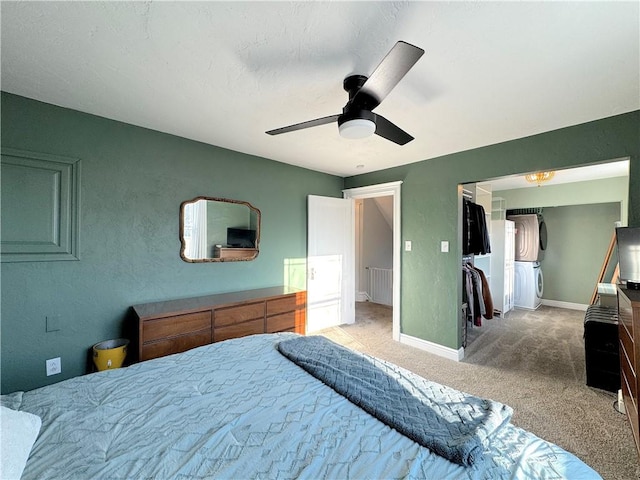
[0,333,600,480]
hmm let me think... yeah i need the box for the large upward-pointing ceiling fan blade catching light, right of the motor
[353,41,424,109]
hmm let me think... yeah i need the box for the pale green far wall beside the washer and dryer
[541,203,620,305]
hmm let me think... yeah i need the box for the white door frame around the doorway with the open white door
[342,181,402,342]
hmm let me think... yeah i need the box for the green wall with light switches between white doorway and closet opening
[345,111,640,349]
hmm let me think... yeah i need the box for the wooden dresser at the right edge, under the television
[618,287,640,454]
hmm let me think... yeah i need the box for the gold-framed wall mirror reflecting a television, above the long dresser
[180,197,260,262]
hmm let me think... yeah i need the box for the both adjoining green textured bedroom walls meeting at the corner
[1,89,640,393]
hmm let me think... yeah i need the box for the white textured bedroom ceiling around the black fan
[1,1,640,176]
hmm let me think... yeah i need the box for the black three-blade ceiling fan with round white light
[266,41,424,145]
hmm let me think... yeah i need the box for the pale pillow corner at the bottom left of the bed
[0,406,42,480]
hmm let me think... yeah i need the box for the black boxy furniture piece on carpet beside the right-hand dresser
[584,305,620,393]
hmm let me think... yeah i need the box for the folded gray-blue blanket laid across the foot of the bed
[278,336,513,466]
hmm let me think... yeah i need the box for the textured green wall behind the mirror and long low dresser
[1,93,343,393]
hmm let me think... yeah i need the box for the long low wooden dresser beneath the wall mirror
[133,287,307,361]
